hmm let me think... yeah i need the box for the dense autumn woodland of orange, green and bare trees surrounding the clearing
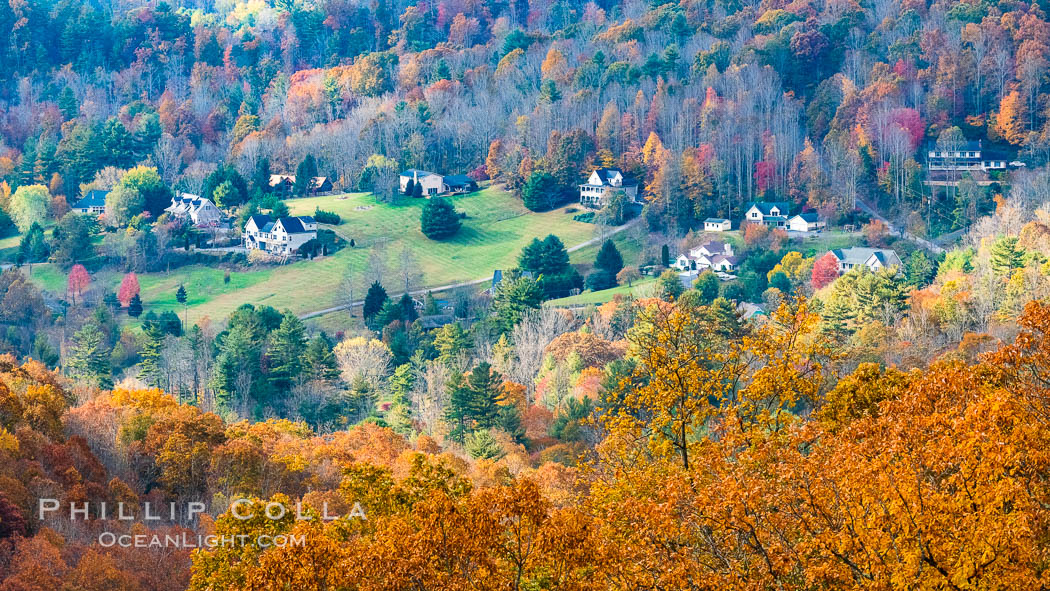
[0,0,1050,591]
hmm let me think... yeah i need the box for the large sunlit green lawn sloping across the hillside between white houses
[169,187,594,321]
